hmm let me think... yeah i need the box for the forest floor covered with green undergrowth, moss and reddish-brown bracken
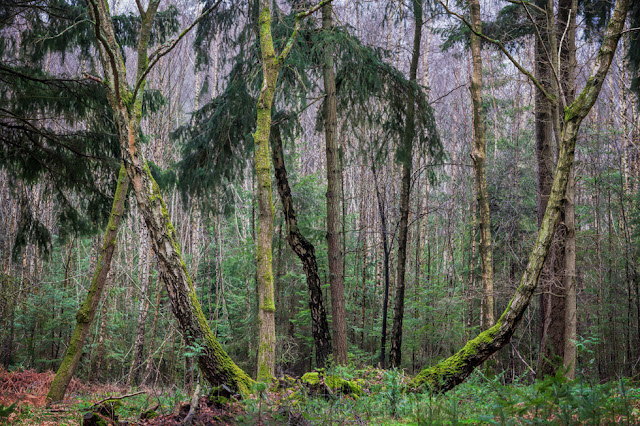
[0,368,640,426]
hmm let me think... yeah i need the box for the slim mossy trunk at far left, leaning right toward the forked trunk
[47,165,129,401]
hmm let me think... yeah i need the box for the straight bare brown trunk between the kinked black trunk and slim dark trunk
[322,0,348,365]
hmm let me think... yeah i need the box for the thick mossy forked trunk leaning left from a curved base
[87,0,252,392]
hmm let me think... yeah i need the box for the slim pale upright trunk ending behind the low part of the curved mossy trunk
[469,0,495,330]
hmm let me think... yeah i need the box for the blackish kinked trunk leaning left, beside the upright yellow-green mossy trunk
[271,126,331,368]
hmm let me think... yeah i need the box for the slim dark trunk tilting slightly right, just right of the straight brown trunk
[389,0,422,367]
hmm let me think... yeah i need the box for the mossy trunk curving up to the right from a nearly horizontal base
[413,0,630,392]
